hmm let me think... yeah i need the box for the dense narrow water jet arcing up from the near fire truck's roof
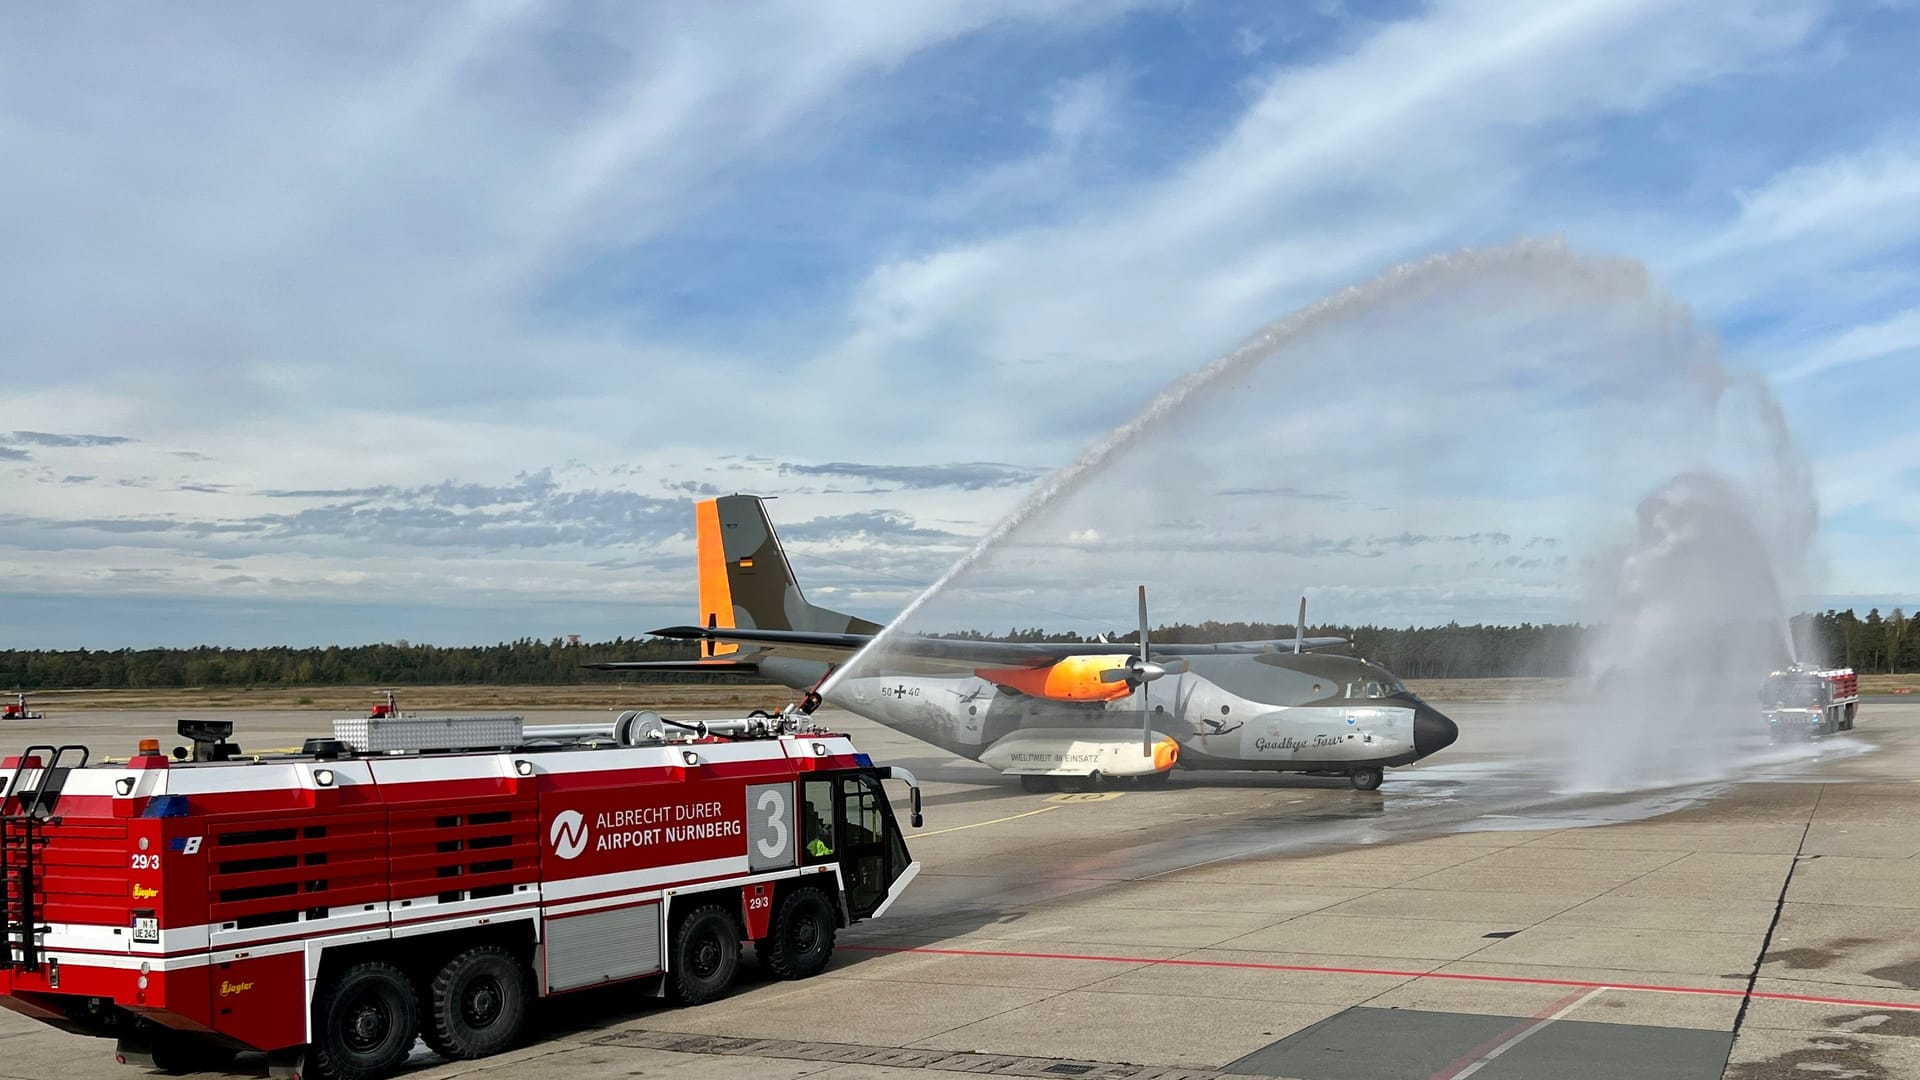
[820,238,1649,698]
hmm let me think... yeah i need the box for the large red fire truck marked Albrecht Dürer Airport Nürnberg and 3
[0,711,920,1080]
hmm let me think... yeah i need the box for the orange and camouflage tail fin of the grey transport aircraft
[695,496,881,655]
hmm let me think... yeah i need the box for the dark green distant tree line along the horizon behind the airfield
[0,609,1920,690]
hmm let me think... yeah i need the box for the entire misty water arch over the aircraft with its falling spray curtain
[822,238,1818,788]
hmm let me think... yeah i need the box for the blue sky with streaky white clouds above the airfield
[0,0,1920,648]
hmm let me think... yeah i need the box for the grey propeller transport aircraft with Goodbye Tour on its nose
[588,496,1459,792]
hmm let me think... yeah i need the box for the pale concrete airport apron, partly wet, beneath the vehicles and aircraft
[0,701,1920,1080]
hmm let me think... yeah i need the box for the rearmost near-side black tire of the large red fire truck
[313,961,420,1080]
